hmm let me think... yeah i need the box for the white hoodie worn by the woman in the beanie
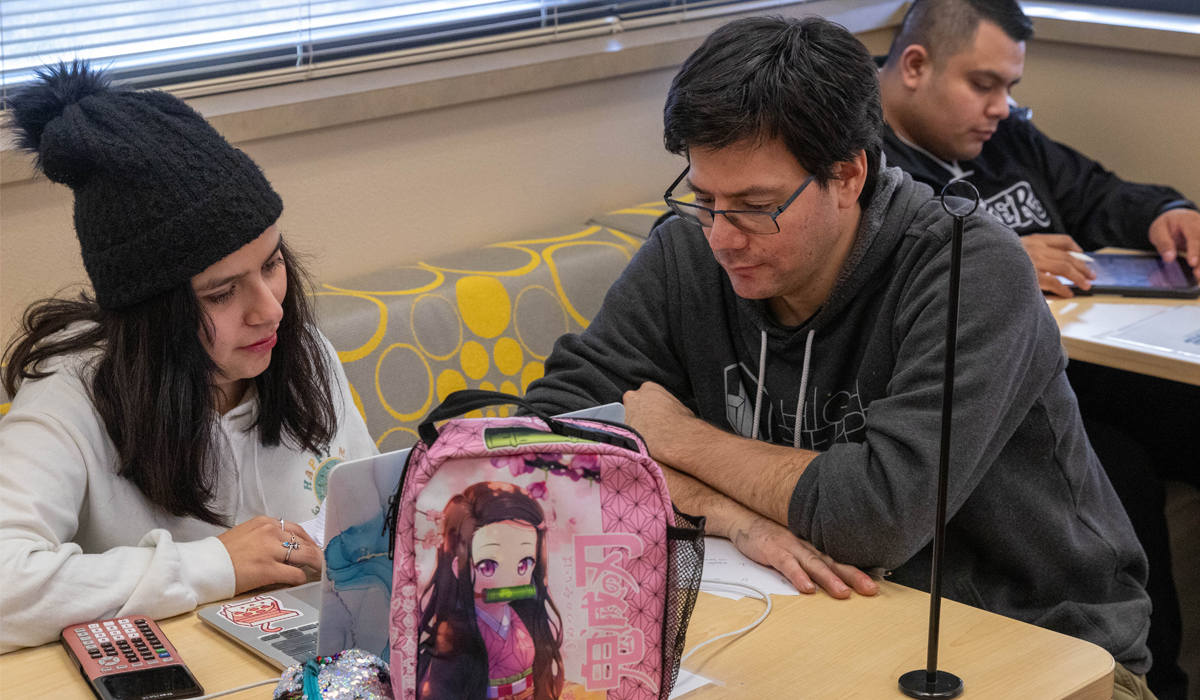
[0,336,379,653]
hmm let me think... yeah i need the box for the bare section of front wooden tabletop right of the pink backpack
[684,582,1114,700]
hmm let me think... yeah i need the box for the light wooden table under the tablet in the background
[1049,295,1200,385]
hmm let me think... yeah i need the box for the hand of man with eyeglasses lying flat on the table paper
[730,511,880,598]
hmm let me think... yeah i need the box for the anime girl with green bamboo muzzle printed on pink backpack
[416,481,563,700]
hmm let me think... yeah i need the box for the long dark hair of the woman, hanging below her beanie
[4,244,337,526]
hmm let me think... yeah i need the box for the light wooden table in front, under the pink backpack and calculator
[0,581,1114,700]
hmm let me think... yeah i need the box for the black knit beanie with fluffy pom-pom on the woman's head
[8,61,283,309]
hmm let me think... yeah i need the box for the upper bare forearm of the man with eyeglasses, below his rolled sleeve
[647,418,820,527]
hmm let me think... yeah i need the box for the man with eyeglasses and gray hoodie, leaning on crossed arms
[527,13,1150,691]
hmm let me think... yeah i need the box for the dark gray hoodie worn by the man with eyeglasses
[527,168,1151,674]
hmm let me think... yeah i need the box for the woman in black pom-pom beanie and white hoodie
[0,62,378,652]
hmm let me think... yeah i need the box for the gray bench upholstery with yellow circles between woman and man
[316,225,656,451]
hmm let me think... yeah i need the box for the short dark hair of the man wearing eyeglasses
[662,17,883,208]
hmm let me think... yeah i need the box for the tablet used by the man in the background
[1060,252,1200,299]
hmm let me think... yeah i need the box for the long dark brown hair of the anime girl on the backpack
[416,481,563,700]
